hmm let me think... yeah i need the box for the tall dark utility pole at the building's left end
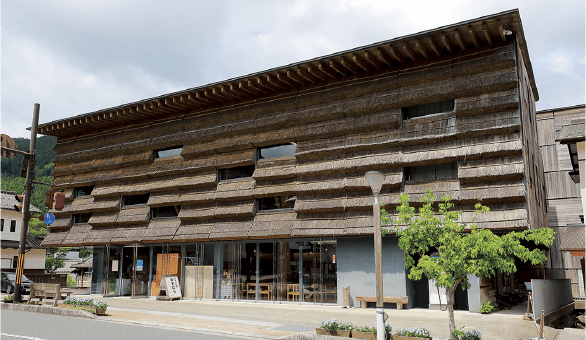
[14,103,41,302]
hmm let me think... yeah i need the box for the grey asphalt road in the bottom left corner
[0,310,244,340]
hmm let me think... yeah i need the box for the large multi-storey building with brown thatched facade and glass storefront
[40,10,546,310]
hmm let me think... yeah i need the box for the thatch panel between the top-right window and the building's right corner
[454,88,519,118]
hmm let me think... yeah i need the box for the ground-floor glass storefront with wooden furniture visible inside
[92,238,337,304]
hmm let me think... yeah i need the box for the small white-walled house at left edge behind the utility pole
[0,190,46,274]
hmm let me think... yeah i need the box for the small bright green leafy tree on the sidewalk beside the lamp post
[381,191,554,340]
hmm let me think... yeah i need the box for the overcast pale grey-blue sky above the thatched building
[0,0,586,137]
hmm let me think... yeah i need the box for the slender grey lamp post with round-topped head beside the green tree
[364,171,386,340]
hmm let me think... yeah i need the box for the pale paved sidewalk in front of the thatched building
[65,295,560,340]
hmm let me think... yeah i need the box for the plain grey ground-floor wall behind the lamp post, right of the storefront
[337,236,412,308]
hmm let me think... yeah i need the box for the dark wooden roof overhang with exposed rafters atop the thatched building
[36,9,539,137]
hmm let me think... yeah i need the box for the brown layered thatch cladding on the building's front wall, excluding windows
[42,44,540,244]
